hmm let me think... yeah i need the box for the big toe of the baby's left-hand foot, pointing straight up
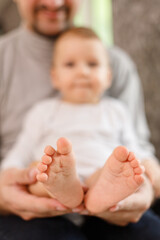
[57,138,72,155]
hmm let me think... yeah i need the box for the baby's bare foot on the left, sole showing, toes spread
[37,138,83,208]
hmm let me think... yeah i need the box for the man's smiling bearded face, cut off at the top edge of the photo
[15,0,80,36]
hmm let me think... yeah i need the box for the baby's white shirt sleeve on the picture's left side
[1,105,44,170]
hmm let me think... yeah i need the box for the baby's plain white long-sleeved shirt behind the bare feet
[1,97,150,180]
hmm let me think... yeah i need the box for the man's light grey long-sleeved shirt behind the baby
[0,27,154,159]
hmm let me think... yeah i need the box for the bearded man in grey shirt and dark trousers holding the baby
[0,0,160,240]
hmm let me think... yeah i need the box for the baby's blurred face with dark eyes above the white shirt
[52,36,111,103]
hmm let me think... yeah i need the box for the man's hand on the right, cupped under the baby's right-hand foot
[82,177,154,226]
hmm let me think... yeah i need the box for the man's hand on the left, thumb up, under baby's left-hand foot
[0,168,69,220]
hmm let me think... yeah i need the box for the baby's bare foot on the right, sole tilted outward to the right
[85,146,144,213]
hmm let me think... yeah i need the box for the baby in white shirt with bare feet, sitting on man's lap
[2,28,158,213]
